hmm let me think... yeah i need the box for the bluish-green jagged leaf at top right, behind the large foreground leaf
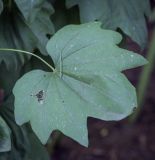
[66,0,150,48]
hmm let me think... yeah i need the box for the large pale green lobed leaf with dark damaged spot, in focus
[13,23,146,146]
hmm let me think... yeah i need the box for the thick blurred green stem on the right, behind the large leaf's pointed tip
[129,29,155,123]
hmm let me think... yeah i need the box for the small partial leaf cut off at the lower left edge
[0,116,11,152]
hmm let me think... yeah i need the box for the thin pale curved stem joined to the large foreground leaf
[0,48,55,72]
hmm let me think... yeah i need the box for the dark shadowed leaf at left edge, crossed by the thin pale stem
[0,12,34,69]
